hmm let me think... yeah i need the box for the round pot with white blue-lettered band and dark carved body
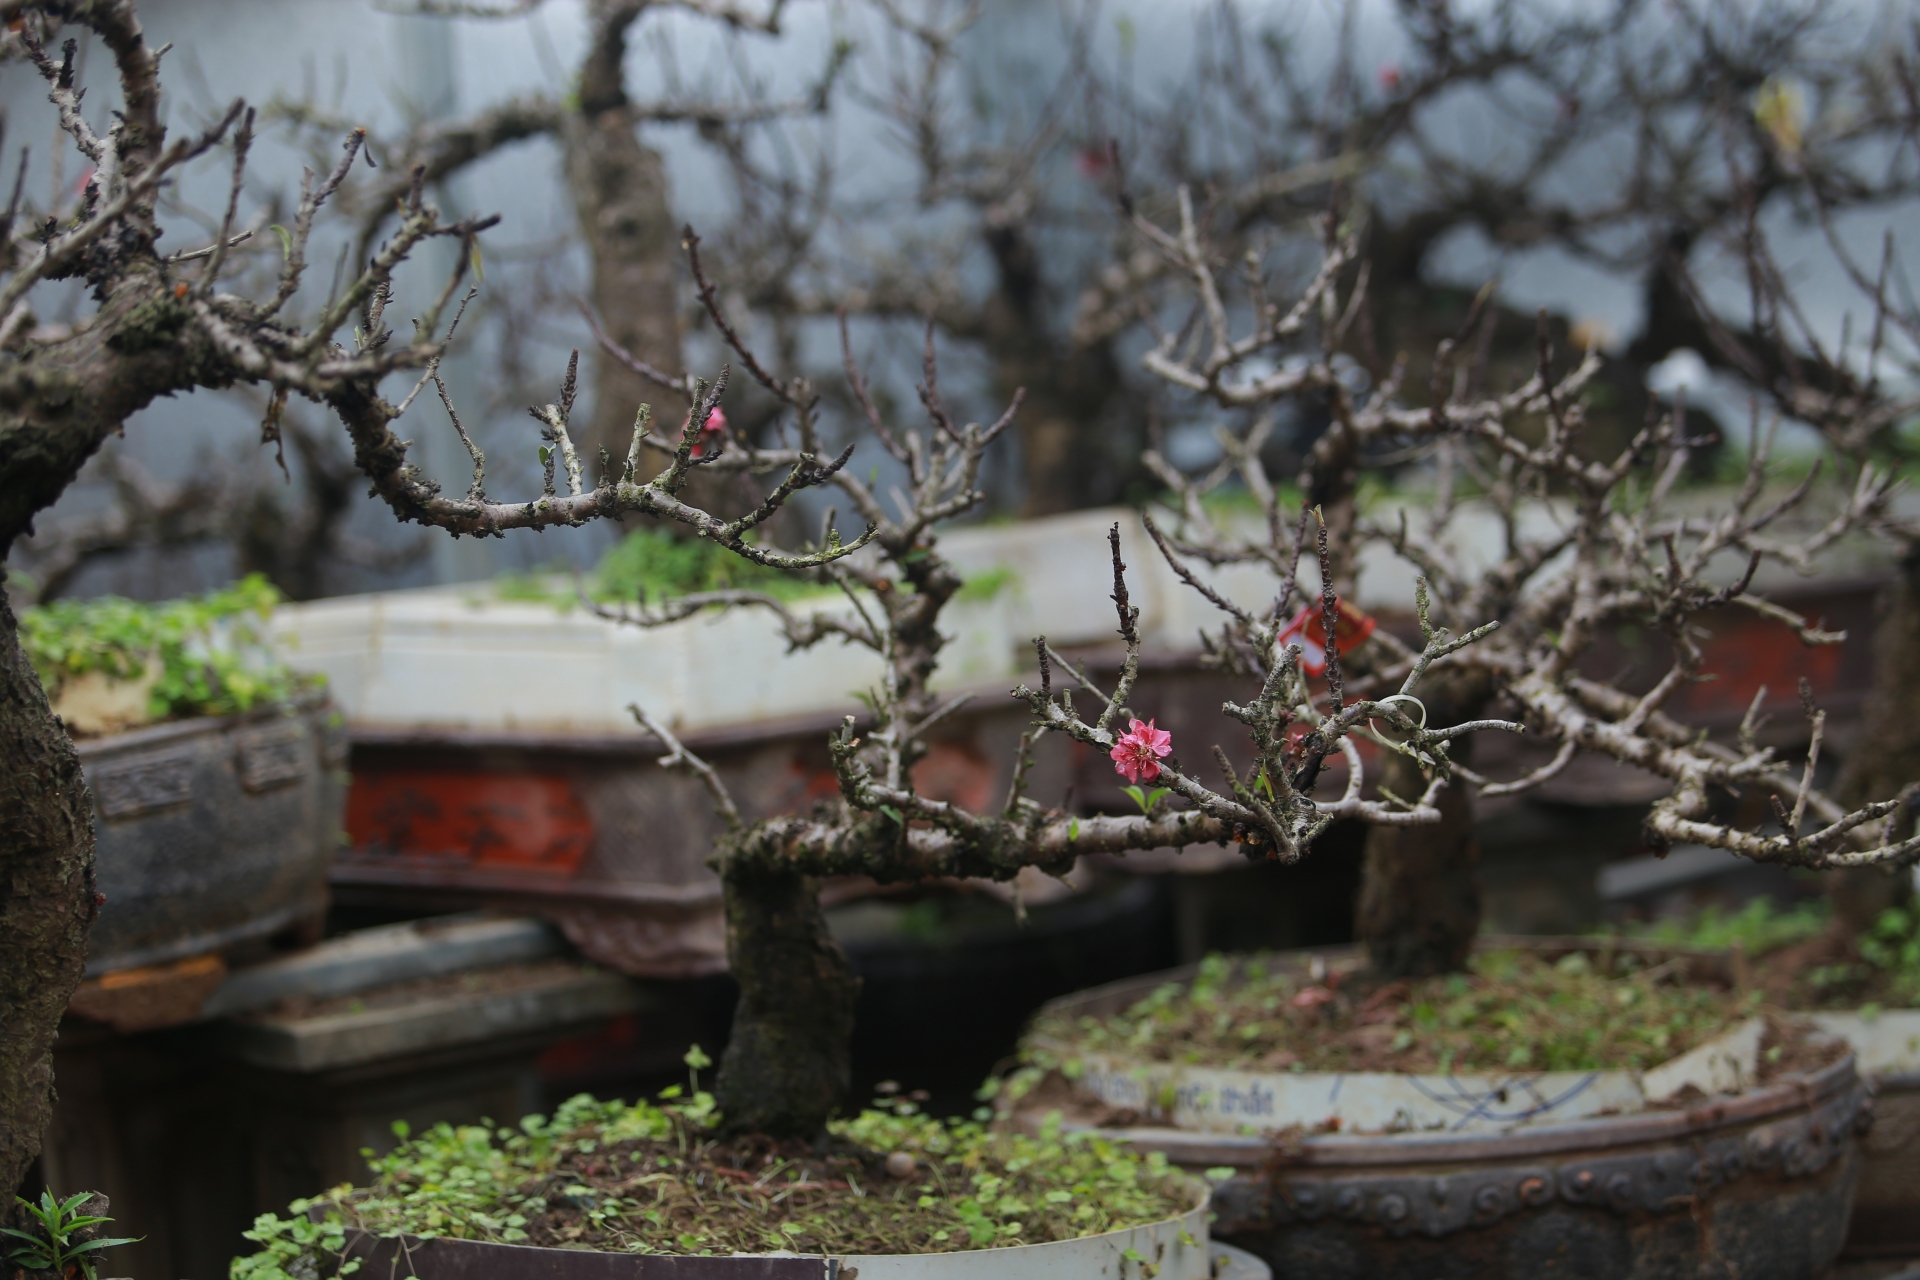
[1014,938,1874,1280]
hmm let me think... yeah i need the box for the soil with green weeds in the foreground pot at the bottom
[234,1094,1198,1280]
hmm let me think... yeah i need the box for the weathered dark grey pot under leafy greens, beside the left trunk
[79,699,346,975]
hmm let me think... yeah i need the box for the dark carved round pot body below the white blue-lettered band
[1021,942,1874,1280]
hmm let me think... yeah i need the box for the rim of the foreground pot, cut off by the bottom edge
[332,1194,1213,1280]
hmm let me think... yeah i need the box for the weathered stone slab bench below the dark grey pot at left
[44,917,652,1276]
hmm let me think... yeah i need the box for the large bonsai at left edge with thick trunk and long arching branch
[0,0,870,1220]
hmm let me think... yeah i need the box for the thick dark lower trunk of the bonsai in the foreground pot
[714,865,860,1138]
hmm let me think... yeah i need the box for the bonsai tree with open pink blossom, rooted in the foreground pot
[568,234,1517,1136]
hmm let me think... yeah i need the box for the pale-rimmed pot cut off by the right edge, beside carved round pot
[1814,1009,1920,1257]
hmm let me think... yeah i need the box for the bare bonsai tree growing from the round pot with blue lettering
[1098,188,1920,977]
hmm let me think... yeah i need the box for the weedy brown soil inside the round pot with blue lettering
[1025,944,1763,1075]
